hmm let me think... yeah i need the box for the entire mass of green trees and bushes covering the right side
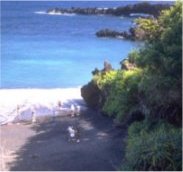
[81,1,182,170]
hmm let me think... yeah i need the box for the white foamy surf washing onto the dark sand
[0,87,84,124]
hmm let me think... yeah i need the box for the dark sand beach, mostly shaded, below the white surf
[0,110,126,171]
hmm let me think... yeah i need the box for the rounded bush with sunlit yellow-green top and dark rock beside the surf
[82,68,143,121]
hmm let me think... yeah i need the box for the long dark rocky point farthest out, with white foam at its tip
[47,2,170,17]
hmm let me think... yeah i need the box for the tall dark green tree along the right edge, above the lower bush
[136,1,182,125]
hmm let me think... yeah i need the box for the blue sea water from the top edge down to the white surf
[1,1,171,88]
